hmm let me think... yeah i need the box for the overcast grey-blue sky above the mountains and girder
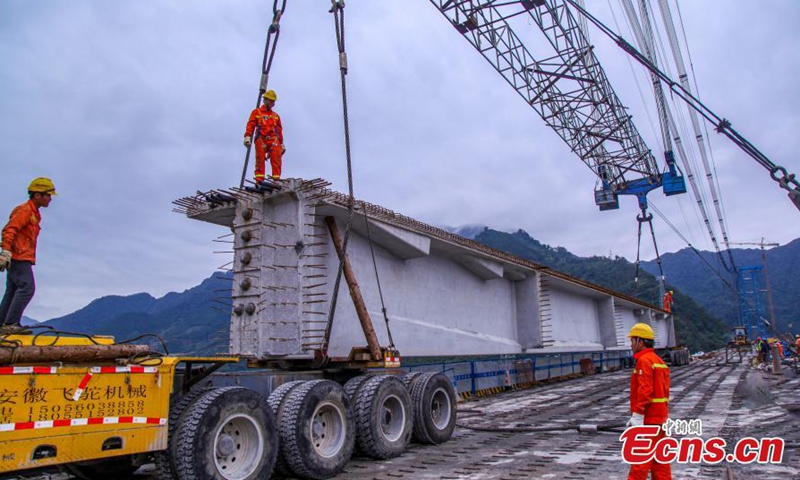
[0,0,800,320]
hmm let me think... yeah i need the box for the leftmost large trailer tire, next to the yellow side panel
[174,387,278,480]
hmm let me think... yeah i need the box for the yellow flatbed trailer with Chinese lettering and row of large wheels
[0,335,456,480]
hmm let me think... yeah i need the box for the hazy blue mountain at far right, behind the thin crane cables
[642,238,800,332]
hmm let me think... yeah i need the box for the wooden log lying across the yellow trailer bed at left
[0,345,150,365]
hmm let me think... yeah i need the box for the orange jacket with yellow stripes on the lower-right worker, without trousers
[631,348,669,425]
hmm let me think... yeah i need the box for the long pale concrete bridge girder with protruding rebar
[183,179,675,358]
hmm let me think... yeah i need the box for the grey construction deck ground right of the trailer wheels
[4,355,800,480]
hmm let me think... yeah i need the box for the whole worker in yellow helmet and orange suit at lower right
[628,323,672,480]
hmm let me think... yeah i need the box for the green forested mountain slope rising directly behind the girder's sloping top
[475,228,729,351]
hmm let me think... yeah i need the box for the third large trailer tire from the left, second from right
[353,375,414,460]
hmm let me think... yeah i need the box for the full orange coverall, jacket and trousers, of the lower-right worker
[628,348,672,480]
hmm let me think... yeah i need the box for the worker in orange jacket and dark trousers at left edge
[0,177,56,327]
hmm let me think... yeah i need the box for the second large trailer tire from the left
[281,380,355,479]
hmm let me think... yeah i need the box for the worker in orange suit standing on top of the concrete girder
[244,90,286,185]
